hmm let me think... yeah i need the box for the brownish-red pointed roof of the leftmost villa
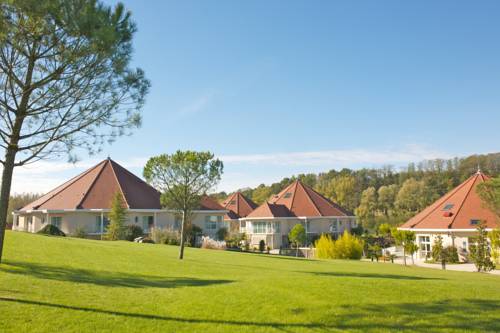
[21,158,160,211]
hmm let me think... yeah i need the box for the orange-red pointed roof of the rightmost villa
[400,170,498,229]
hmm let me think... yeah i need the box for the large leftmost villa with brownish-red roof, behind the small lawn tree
[12,158,227,237]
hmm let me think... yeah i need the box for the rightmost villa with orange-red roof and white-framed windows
[398,171,499,260]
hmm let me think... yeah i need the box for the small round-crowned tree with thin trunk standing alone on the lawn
[143,150,223,259]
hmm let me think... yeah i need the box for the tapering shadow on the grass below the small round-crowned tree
[0,261,234,288]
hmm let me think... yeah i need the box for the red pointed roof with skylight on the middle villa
[248,181,353,218]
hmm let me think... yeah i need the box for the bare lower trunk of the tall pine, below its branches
[0,147,16,263]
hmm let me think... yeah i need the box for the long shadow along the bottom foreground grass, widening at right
[0,297,500,332]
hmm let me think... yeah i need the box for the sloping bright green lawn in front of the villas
[0,232,500,333]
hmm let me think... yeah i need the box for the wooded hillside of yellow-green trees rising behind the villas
[217,153,500,231]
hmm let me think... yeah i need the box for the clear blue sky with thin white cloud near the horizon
[13,0,500,192]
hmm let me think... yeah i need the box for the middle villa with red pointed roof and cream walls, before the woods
[239,181,356,249]
